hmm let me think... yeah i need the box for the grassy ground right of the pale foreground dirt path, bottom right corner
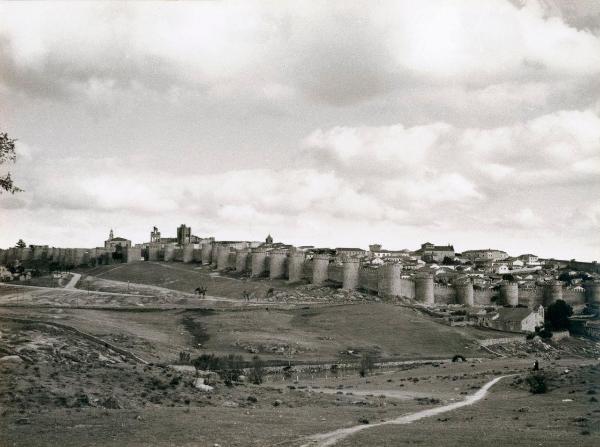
[337,365,600,447]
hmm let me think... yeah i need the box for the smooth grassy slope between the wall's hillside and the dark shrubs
[5,298,498,362]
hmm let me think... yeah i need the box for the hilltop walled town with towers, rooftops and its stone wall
[0,224,600,334]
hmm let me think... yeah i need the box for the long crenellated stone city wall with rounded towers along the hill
[0,242,600,308]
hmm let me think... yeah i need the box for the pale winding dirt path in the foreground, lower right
[302,376,508,447]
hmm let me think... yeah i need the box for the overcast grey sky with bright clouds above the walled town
[0,0,600,261]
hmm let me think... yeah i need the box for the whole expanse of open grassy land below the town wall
[0,264,600,447]
